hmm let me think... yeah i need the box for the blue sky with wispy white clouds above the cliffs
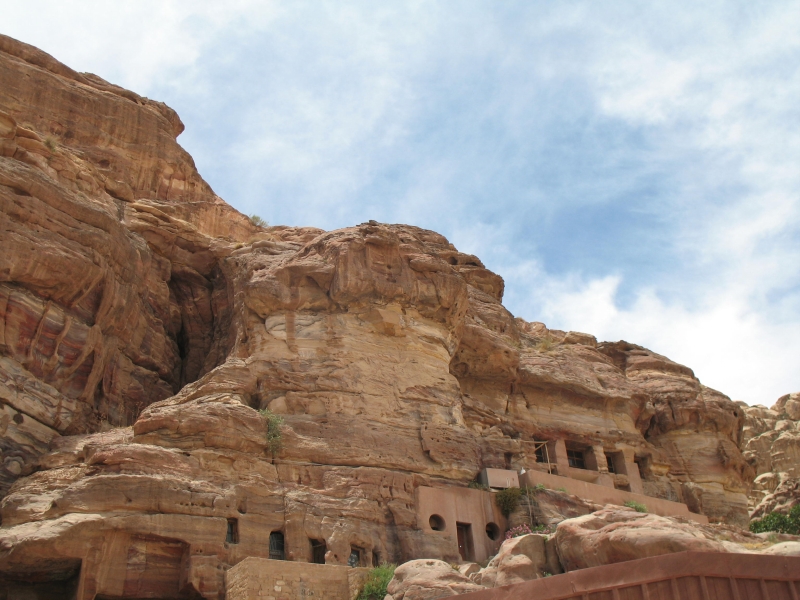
[0,0,800,405]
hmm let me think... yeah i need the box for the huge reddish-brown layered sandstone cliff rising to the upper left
[0,36,753,598]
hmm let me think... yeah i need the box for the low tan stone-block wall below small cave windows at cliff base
[225,558,369,600]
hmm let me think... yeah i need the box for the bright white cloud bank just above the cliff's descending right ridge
[512,274,800,406]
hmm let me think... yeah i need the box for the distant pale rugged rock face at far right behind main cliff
[742,393,800,518]
